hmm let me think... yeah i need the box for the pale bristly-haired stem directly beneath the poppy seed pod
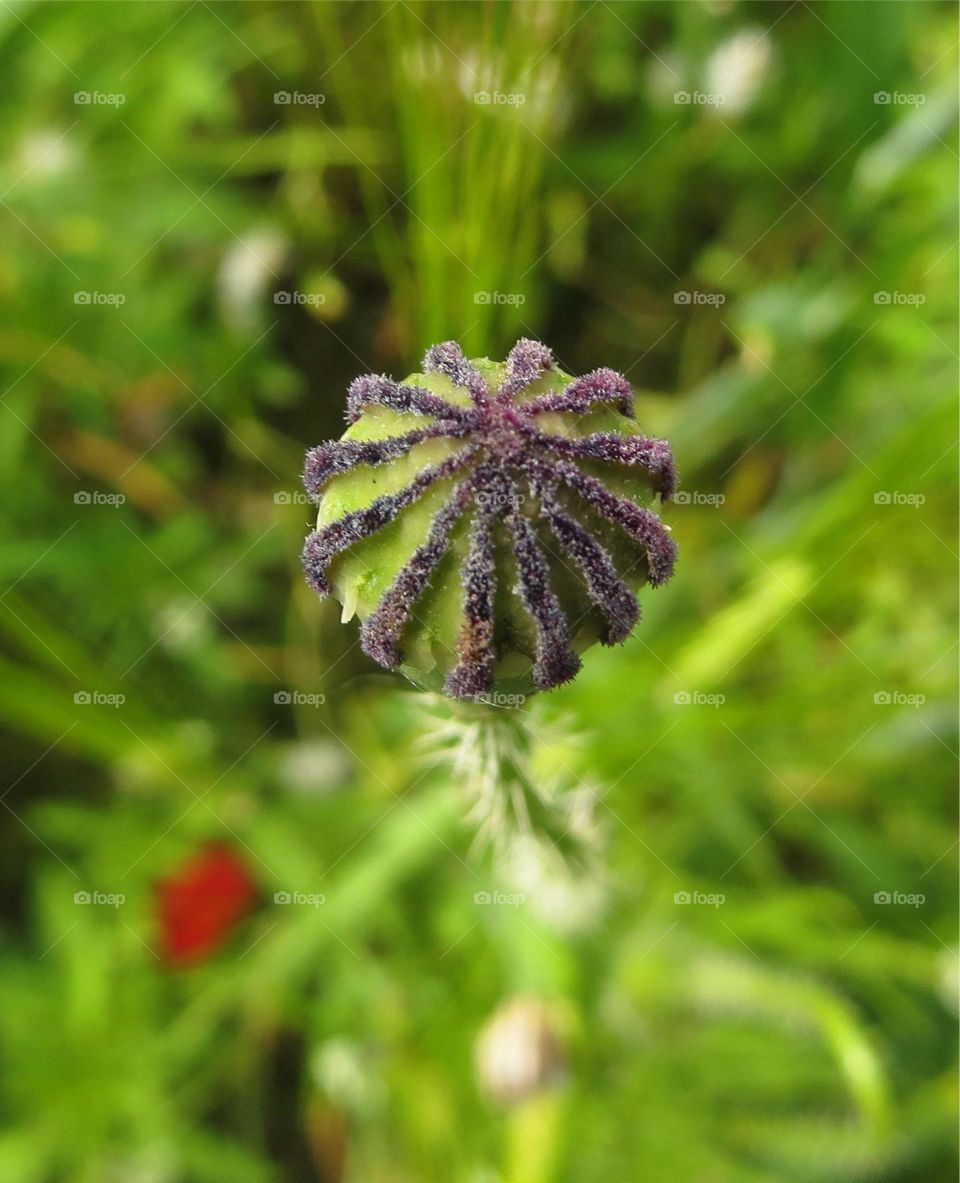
[415,697,606,931]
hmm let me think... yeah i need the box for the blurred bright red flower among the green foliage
[155,843,257,969]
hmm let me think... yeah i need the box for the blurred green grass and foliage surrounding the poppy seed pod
[0,0,956,1183]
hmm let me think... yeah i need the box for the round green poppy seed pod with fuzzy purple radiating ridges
[303,340,677,700]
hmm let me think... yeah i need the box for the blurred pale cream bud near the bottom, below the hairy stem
[476,997,566,1106]
